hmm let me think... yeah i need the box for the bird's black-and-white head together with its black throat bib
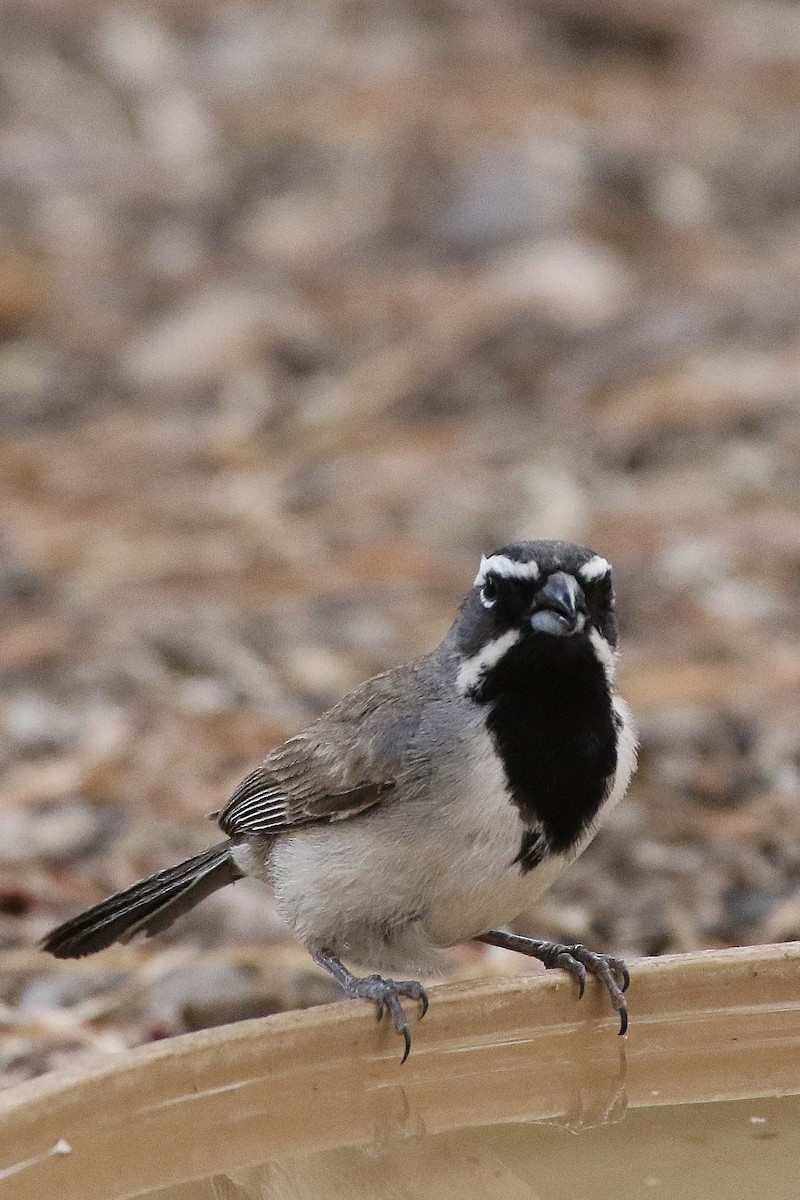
[453,541,631,872]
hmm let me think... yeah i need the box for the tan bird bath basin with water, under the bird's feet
[0,943,800,1200]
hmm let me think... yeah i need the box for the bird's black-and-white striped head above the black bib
[458,541,616,698]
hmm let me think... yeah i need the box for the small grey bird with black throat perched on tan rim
[42,540,637,1062]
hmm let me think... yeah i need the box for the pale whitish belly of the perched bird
[251,738,566,971]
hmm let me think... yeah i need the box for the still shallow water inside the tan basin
[146,1097,800,1200]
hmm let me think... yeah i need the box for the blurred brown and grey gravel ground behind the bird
[0,0,800,1084]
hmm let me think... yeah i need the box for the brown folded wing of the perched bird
[219,664,434,838]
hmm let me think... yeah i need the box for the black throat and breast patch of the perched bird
[475,634,616,872]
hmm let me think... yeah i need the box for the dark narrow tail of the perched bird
[42,841,242,959]
